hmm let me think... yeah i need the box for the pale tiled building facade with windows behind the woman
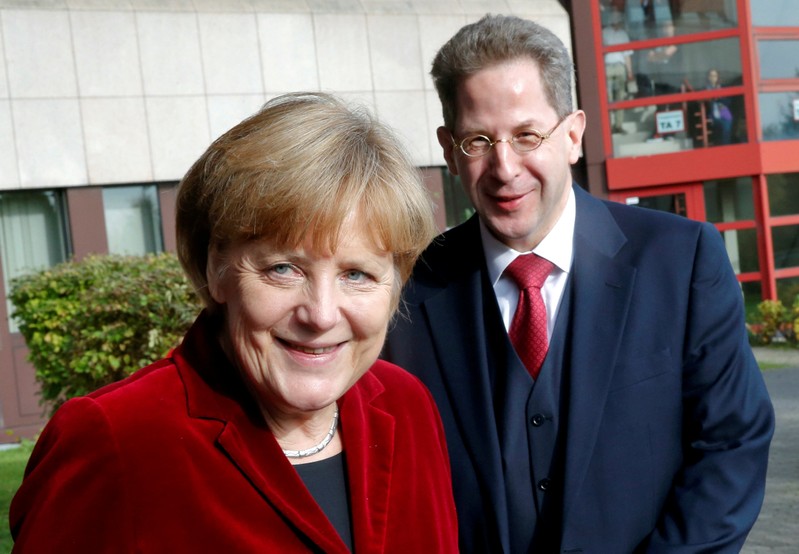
[0,0,571,442]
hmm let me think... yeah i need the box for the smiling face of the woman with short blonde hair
[208,220,399,415]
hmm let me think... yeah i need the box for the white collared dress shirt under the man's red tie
[480,189,576,337]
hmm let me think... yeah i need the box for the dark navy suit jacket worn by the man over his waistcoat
[385,186,774,554]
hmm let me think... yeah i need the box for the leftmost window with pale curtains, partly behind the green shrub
[0,190,70,332]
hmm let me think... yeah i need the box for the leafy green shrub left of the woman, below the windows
[10,254,200,412]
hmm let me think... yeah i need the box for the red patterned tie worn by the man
[505,254,555,379]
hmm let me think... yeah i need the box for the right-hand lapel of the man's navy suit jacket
[563,187,636,523]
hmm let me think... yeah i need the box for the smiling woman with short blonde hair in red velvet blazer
[10,94,457,553]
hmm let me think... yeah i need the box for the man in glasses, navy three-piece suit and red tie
[386,16,773,554]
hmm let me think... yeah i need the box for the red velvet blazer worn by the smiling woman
[10,315,457,554]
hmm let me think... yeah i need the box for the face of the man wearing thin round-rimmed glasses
[438,59,585,252]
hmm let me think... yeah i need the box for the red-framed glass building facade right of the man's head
[571,0,799,312]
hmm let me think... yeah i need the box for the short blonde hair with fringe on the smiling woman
[176,93,436,309]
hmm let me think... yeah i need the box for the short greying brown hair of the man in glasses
[430,15,574,131]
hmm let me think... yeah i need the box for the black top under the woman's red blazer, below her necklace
[294,453,353,552]
